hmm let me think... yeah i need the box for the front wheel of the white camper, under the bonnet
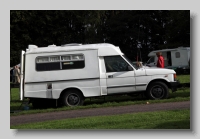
[147,82,169,99]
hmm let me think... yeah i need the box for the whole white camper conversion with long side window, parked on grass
[20,43,178,106]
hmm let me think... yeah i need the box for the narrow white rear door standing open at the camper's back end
[19,51,25,100]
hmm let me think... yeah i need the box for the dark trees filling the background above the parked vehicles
[10,10,190,66]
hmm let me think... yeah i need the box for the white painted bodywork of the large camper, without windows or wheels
[20,44,175,100]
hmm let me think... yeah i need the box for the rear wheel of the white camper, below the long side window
[62,89,84,106]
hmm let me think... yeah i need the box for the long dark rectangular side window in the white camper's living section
[36,54,85,71]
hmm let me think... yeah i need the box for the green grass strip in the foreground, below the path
[10,109,190,129]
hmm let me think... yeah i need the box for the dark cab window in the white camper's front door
[104,56,129,72]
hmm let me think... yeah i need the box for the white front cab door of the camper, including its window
[104,56,135,94]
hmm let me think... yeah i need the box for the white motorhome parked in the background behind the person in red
[146,47,190,73]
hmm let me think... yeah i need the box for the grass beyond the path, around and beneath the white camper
[10,75,190,116]
